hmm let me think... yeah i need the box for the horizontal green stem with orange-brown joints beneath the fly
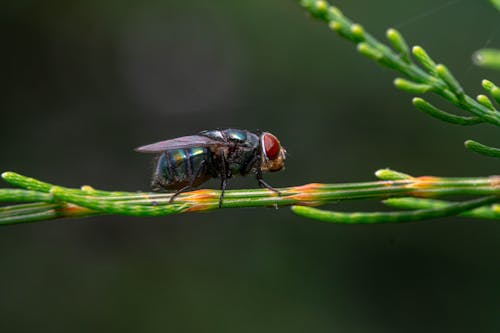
[0,169,500,225]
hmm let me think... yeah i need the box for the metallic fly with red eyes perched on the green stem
[136,128,286,207]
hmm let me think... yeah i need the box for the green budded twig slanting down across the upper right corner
[300,0,500,156]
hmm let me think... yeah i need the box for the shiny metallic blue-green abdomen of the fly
[152,147,210,189]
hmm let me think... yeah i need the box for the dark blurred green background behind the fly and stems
[0,0,500,332]
